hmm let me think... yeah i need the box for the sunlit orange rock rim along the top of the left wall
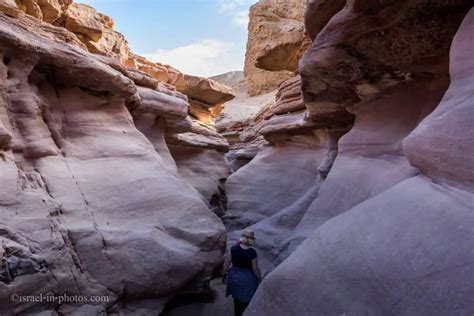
[0,0,234,125]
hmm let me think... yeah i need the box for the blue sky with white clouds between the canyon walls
[76,0,257,77]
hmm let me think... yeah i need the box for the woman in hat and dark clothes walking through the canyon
[224,229,262,316]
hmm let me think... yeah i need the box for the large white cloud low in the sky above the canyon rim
[144,39,245,77]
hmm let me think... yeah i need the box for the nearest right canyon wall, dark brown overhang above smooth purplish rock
[247,0,474,315]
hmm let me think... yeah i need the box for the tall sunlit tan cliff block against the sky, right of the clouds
[245,0,309,95]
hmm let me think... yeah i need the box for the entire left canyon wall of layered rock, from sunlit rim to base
[0,1,232,315]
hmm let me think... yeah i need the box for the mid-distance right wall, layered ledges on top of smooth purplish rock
[219,57,353,272]
